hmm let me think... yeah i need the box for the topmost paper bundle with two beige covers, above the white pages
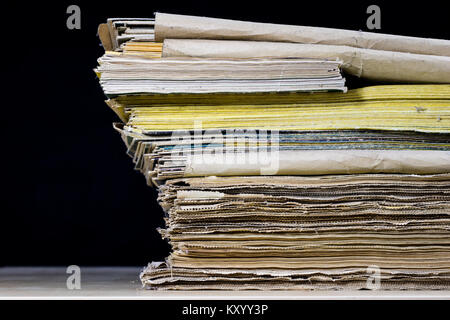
[98,13,450,83]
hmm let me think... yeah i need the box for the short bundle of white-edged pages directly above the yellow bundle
[96,53,346,96]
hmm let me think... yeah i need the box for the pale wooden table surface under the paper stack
[0,267,450,300]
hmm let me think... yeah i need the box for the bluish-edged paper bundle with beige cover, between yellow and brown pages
[116,126,450,185]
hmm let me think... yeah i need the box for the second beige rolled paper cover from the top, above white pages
[163,39,450,83]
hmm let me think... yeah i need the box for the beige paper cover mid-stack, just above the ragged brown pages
[184,150,450,177]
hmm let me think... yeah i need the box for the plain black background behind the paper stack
[0,0,450,266]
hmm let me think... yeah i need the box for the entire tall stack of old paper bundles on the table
[96,14,450,289]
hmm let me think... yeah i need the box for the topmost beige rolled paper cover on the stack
[155,12,450,57]
